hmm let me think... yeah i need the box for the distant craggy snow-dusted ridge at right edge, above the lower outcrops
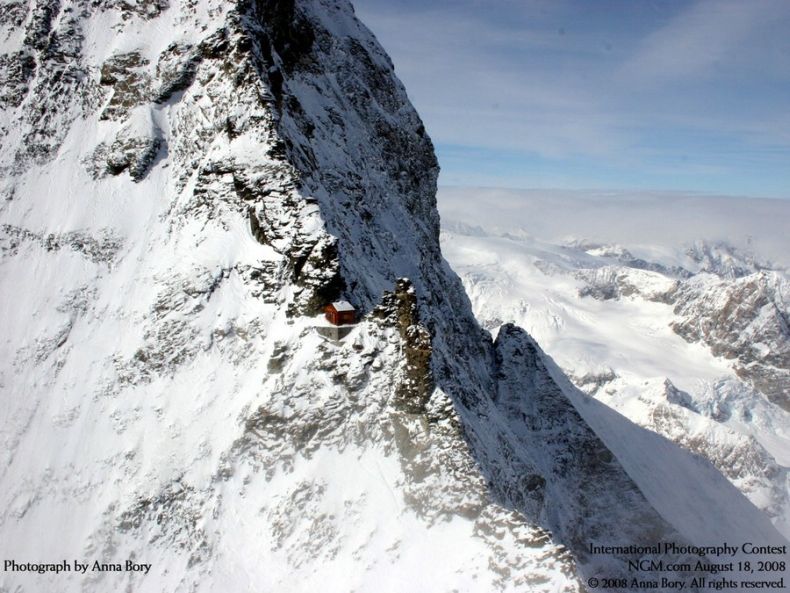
[575,241,790,410]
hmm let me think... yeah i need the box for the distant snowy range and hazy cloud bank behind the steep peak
[440,188,790,535]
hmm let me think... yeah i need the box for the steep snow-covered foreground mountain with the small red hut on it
[0,0,784,592]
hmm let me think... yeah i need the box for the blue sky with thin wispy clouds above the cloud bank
[354,0,790,198]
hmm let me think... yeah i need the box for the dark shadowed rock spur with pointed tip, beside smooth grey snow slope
[483,324,688,568]
